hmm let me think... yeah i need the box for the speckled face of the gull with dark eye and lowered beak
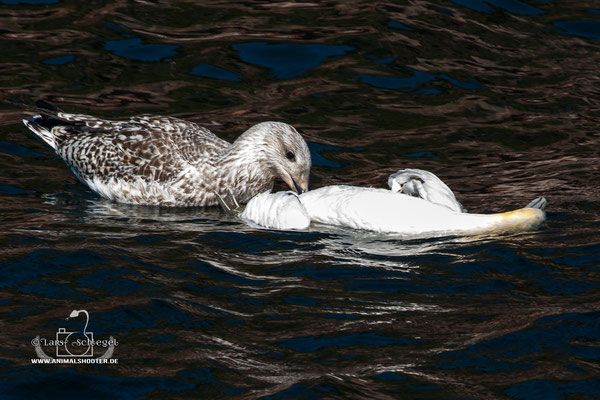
[257,122,311,194]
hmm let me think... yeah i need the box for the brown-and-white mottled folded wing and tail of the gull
[24,110,230,182]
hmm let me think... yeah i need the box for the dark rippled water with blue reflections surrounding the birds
[0,0,600,400]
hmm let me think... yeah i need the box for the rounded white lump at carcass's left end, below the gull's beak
[241,191,310,230]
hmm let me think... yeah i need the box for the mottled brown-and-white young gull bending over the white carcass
[23,108,311,207]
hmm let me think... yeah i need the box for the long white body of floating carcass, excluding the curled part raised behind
[244,185,545,238]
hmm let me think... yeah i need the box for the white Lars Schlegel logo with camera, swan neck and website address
[31,310,119,364]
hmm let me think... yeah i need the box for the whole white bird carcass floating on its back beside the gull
[242,169,546,238]
